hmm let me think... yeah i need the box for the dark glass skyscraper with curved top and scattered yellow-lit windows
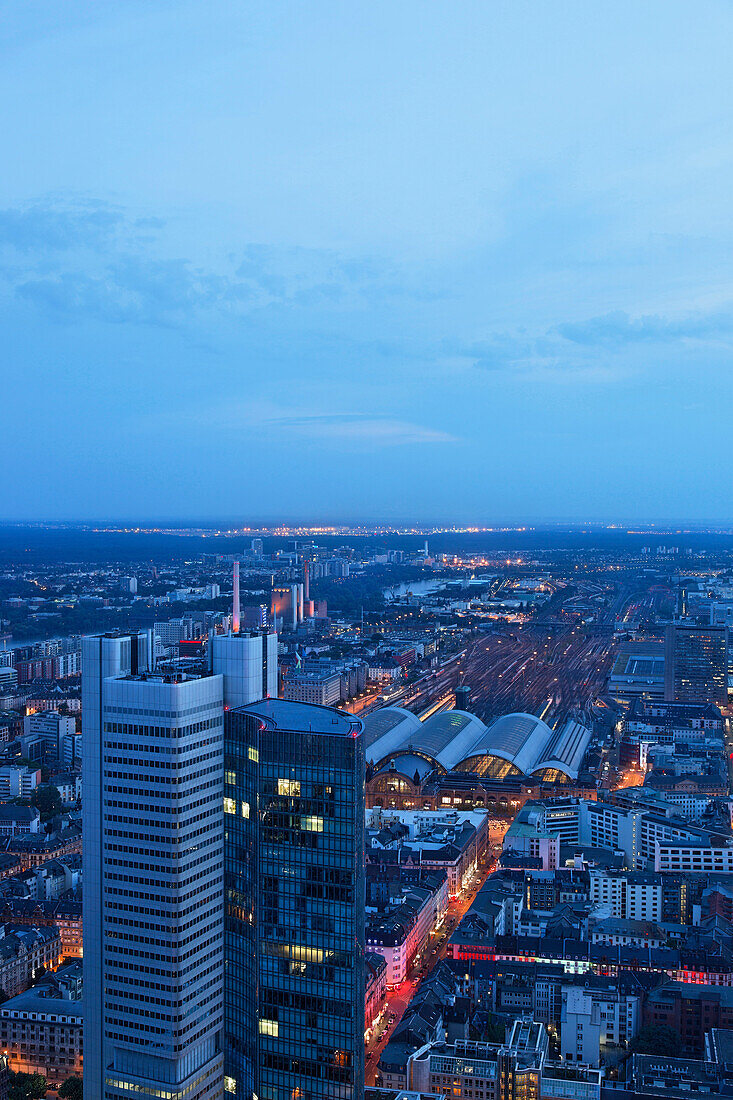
[225,700,364,1100]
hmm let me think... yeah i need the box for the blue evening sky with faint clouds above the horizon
[0,0,733,524]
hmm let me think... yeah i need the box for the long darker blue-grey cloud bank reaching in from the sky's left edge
[0,200,398,327]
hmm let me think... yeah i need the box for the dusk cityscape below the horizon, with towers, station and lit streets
[0,527,733,1100]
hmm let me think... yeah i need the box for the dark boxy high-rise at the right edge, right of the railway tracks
[665,623,727,703]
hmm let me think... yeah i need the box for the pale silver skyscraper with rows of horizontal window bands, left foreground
[83,635,223,1100]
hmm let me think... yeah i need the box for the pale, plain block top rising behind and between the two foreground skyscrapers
[214,630,277,708]
